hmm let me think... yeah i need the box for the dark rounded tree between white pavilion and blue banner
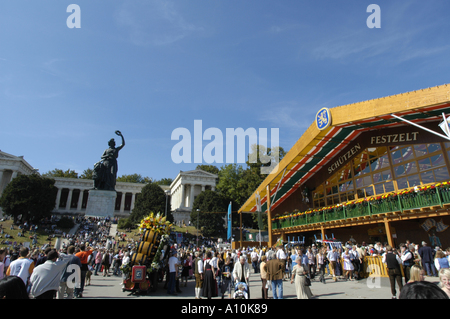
[190,190,229,237]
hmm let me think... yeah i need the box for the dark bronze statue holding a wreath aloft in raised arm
[93,131,125,191]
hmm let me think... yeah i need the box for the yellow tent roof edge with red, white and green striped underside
[239,84,450,213]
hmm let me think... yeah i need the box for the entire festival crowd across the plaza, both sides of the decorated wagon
[0,212,450,299]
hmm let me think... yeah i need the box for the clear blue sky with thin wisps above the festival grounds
[0,0,450,179]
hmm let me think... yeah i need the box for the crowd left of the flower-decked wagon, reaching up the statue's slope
[0,217,141,299]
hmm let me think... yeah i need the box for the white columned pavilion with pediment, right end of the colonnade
[170,169,218,225]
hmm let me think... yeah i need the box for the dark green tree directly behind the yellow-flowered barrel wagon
[129,183,173,223]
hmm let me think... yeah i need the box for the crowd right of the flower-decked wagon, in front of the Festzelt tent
[163,241,450,299]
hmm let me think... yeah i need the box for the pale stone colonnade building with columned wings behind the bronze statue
[0,151,218,225]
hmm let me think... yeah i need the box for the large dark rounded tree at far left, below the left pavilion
[0,174,58,223]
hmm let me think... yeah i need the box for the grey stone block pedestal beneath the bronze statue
[85,189,117,218]
